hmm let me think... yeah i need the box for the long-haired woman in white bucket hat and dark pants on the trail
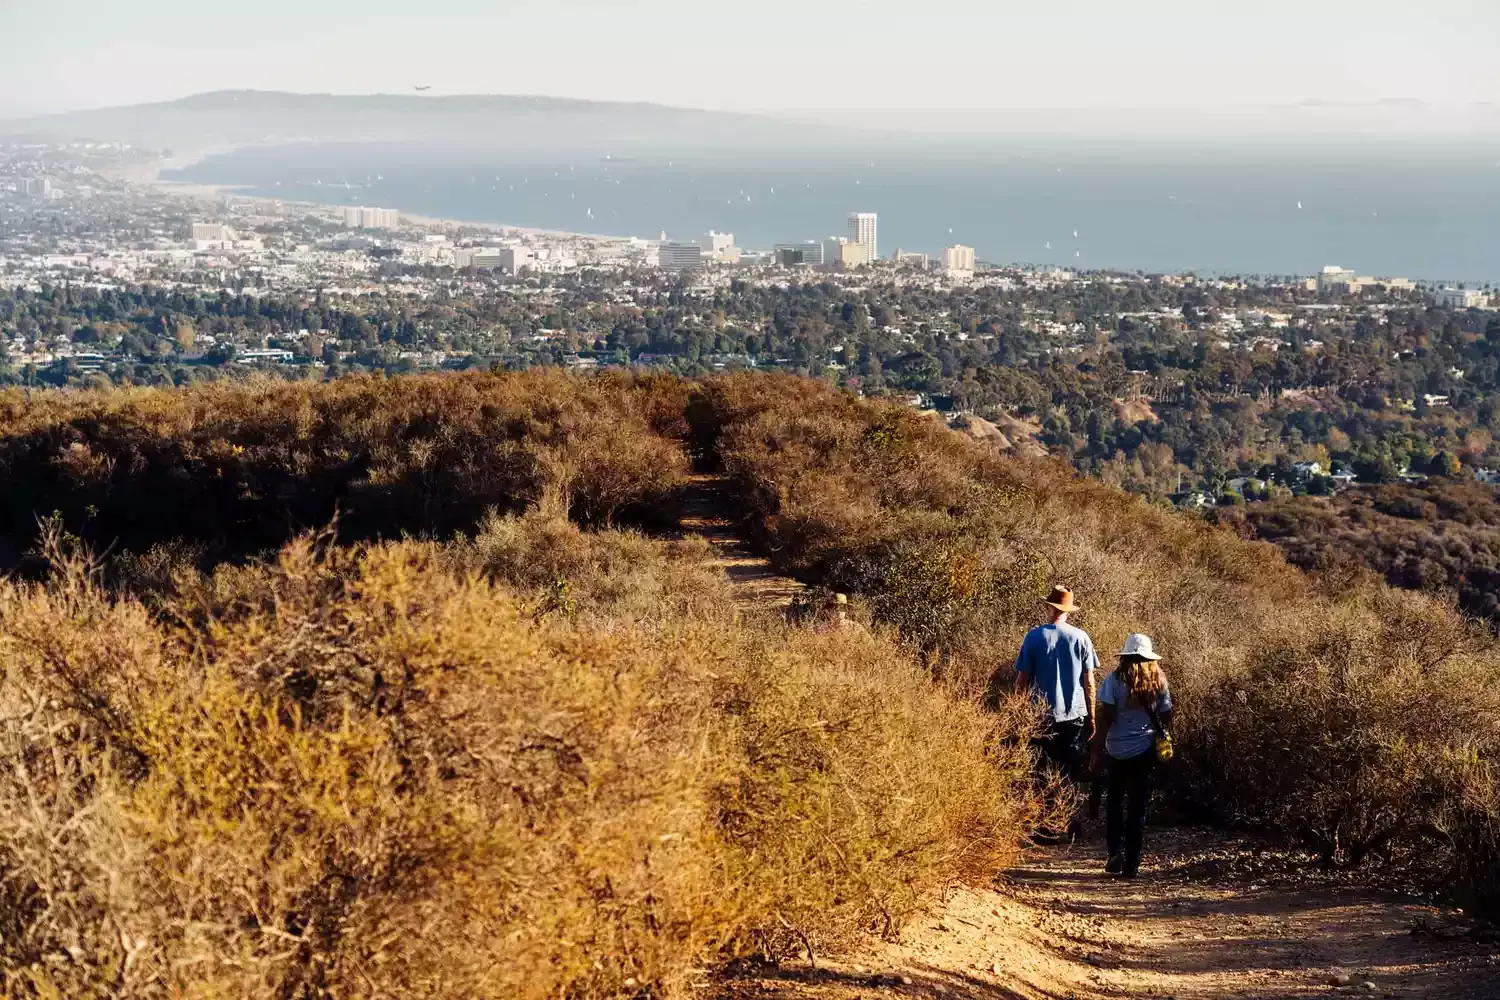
[1091,633,1173,879]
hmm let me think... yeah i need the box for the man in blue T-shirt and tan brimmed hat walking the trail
[1016,586,1100,781]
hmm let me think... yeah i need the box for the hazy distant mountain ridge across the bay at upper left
[0,90,836,156]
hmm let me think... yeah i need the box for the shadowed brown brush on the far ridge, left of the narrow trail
[0,372,686,567]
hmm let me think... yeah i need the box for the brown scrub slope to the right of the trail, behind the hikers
[689,376,1500,903]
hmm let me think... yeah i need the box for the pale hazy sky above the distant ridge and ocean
[0,0,1500,114]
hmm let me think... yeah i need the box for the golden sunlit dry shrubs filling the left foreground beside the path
[0,527,1034,999]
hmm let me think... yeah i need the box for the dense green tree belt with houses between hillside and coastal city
[0,276,1500,495]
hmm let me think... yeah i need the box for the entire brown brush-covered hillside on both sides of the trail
[0,370,1500,1000]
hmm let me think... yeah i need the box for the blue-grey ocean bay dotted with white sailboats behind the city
[167,138,1500,283]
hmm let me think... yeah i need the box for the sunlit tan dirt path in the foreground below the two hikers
[719,831,1500,1000]
